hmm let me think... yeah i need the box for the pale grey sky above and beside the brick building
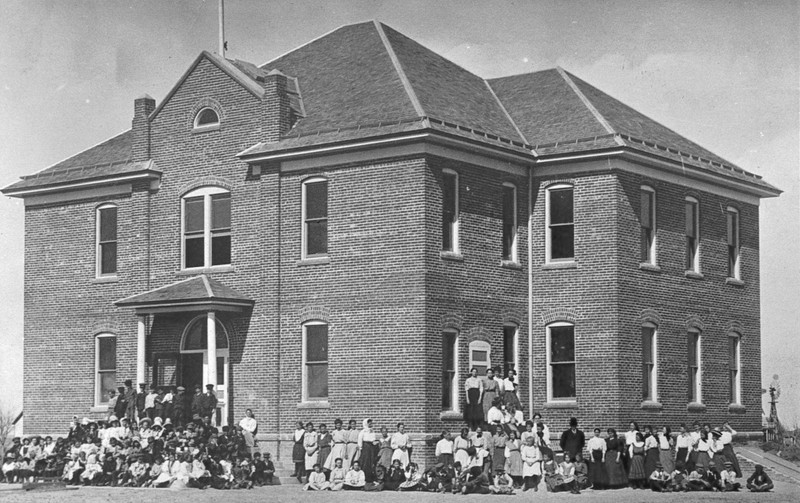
[0,0,800,424]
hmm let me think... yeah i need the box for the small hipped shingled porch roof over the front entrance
[114,274,255,314]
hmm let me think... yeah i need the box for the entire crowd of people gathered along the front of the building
[2,369,773,494]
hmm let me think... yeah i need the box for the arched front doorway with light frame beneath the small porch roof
[180,314,229,426]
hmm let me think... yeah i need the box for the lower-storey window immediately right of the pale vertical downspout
[547,323,576,400]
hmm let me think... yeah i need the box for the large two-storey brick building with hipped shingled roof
[3,22,780,464]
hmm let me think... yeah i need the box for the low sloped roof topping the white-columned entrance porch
[114,274,254,308]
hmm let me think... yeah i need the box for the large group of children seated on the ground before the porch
[2,416,275,489]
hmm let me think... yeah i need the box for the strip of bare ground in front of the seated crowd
[0,481,800,503]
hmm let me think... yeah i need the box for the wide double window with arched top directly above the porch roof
[183,187,231,269]
